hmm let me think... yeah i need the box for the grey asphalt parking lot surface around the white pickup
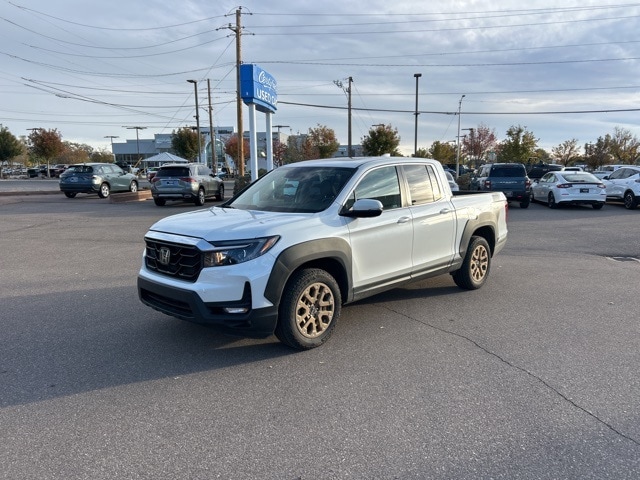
[0,183,640,480]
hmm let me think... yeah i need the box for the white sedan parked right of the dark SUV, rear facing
[531,171,607,210]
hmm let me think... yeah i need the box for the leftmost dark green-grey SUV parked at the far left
[60,163,138,198]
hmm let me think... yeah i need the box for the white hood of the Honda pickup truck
[150,207,318,240]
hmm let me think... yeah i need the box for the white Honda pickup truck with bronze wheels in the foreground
[138,157,508,349]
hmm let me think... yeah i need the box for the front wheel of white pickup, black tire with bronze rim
[275,268,342,350]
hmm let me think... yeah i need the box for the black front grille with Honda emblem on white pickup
[145,238,202,282]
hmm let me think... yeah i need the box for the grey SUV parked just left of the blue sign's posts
[151,163,224,207]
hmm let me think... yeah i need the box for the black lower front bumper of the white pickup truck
[138,276,278,338]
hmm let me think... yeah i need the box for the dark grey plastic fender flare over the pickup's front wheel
[264,238,353,306]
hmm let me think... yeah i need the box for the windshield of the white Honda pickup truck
[224,167,355,213]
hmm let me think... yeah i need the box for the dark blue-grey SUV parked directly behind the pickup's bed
[471,163,531,208]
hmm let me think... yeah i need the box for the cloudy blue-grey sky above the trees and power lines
[0,0,640,155]
